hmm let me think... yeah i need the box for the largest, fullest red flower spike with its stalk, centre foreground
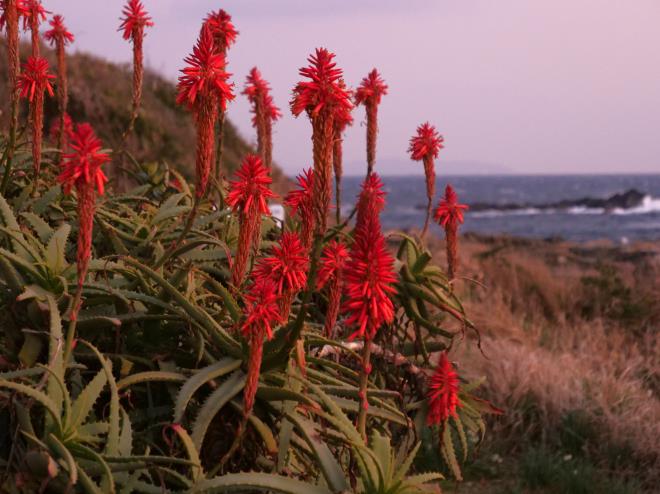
[343,173,396,440]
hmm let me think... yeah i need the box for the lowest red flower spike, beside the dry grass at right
[426,352,462,426]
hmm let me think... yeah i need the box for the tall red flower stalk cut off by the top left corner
[0,0,29,193]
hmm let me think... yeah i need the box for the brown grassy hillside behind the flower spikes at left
[0,43,287,191]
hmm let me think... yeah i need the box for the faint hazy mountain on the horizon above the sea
[346,158,515,176]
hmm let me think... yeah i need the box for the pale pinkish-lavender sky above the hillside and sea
[43,0,660,174]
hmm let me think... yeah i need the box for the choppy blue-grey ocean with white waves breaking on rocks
[342,175,660,244]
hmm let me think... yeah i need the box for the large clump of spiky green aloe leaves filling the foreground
[0,21,498,484]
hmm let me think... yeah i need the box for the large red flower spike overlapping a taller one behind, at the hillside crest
[177,25,234,199]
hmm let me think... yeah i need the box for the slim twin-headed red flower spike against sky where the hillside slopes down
[243,67,282,168]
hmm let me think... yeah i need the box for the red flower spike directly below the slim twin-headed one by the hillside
[227,155,275,288]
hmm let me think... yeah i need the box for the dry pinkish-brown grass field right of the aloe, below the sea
[431,233,660,482]
